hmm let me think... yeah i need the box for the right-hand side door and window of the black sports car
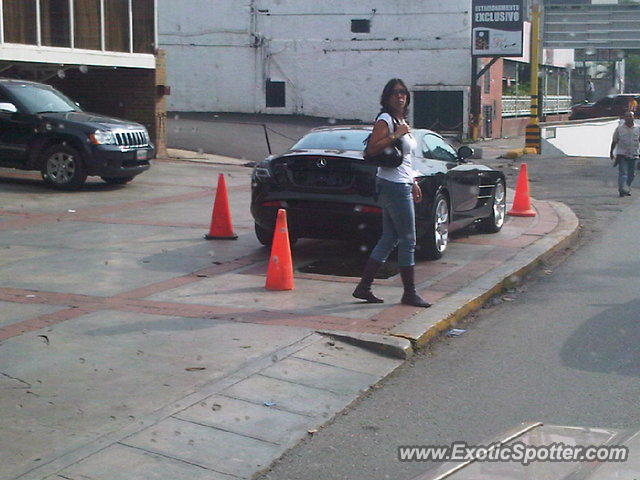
[423,133,480,221]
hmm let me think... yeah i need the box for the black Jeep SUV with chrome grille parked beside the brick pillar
[0,79,155,190]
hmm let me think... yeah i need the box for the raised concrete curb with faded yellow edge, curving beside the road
[389,201,578,348]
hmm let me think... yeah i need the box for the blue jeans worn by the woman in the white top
[371,178,416,267]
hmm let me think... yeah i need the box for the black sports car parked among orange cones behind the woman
[251,126,506,259]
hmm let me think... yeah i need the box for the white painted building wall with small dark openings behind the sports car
[159,0,471,121]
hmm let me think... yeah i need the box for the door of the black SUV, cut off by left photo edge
[0,91,36,166]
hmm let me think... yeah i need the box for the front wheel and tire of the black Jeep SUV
[40,144,87,190]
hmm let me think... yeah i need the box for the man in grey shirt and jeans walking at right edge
[609,111,640,197]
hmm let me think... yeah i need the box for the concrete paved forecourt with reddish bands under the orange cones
[0,151,578,480]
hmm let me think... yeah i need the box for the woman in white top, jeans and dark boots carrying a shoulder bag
[353,78,431,307]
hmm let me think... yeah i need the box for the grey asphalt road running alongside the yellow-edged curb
[170,115,640,480]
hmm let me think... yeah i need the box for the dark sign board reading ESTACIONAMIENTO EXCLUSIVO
[471,0,524,57]
